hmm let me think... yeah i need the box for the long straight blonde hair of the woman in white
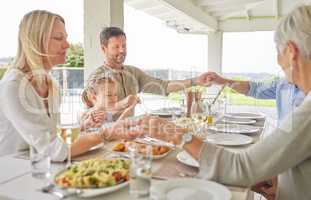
[8,10,65,93]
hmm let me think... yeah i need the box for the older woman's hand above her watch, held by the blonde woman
[140,116,186,145]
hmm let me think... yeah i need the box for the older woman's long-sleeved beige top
[199,92,311,200]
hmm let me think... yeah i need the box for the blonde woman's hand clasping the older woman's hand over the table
[102,119,144,140]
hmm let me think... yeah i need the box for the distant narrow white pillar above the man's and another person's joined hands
[208,32,223,74]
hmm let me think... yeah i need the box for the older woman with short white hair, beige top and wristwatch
[144,6,311,200]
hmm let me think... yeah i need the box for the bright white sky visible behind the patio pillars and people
[0,0,280,74]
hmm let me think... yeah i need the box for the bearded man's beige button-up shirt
[89,65,168,100]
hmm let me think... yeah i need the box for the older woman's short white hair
[274,5,311,59]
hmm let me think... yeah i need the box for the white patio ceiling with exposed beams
[125,0,307,34]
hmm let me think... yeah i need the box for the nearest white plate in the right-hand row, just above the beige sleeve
[205,133,253,146]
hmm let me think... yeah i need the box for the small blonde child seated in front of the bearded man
[81,73,140,129]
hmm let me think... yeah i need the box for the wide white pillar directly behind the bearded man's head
[84,0,124,80]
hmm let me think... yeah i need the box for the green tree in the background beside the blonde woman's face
[65,43,84,67]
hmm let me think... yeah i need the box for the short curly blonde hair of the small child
[81,73,117,108]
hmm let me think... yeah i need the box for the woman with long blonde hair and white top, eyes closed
[0,10,142,161]
